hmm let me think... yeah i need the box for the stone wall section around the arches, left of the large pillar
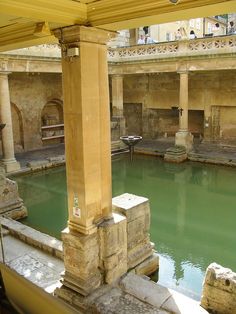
[9,73,62,152]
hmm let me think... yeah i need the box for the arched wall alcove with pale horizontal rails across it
[41,99,64,145]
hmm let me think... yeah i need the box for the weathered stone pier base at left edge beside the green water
[0,166,27,219]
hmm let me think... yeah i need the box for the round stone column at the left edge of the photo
[0,72,20,172]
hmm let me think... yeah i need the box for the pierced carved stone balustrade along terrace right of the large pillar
[108,35,236,62]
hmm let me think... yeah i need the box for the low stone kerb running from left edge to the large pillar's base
[0,217,63,260]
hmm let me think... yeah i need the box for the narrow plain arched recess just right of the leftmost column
[11,103,24,153]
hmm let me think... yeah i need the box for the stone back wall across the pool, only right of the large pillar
[124,70,236,141]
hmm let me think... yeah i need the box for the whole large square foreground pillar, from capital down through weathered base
[55,25,127,300]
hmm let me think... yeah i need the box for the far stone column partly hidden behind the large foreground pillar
[112,74,125,136]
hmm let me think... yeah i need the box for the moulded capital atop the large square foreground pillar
[54,25,116,45]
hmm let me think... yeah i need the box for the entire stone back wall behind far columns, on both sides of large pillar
[0,67,236,153]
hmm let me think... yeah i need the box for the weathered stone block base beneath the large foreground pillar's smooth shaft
[55,213,127,308]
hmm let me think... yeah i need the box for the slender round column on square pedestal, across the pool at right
[175,71,193,151]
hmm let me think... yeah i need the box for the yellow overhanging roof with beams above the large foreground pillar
[0,0,236,51]
